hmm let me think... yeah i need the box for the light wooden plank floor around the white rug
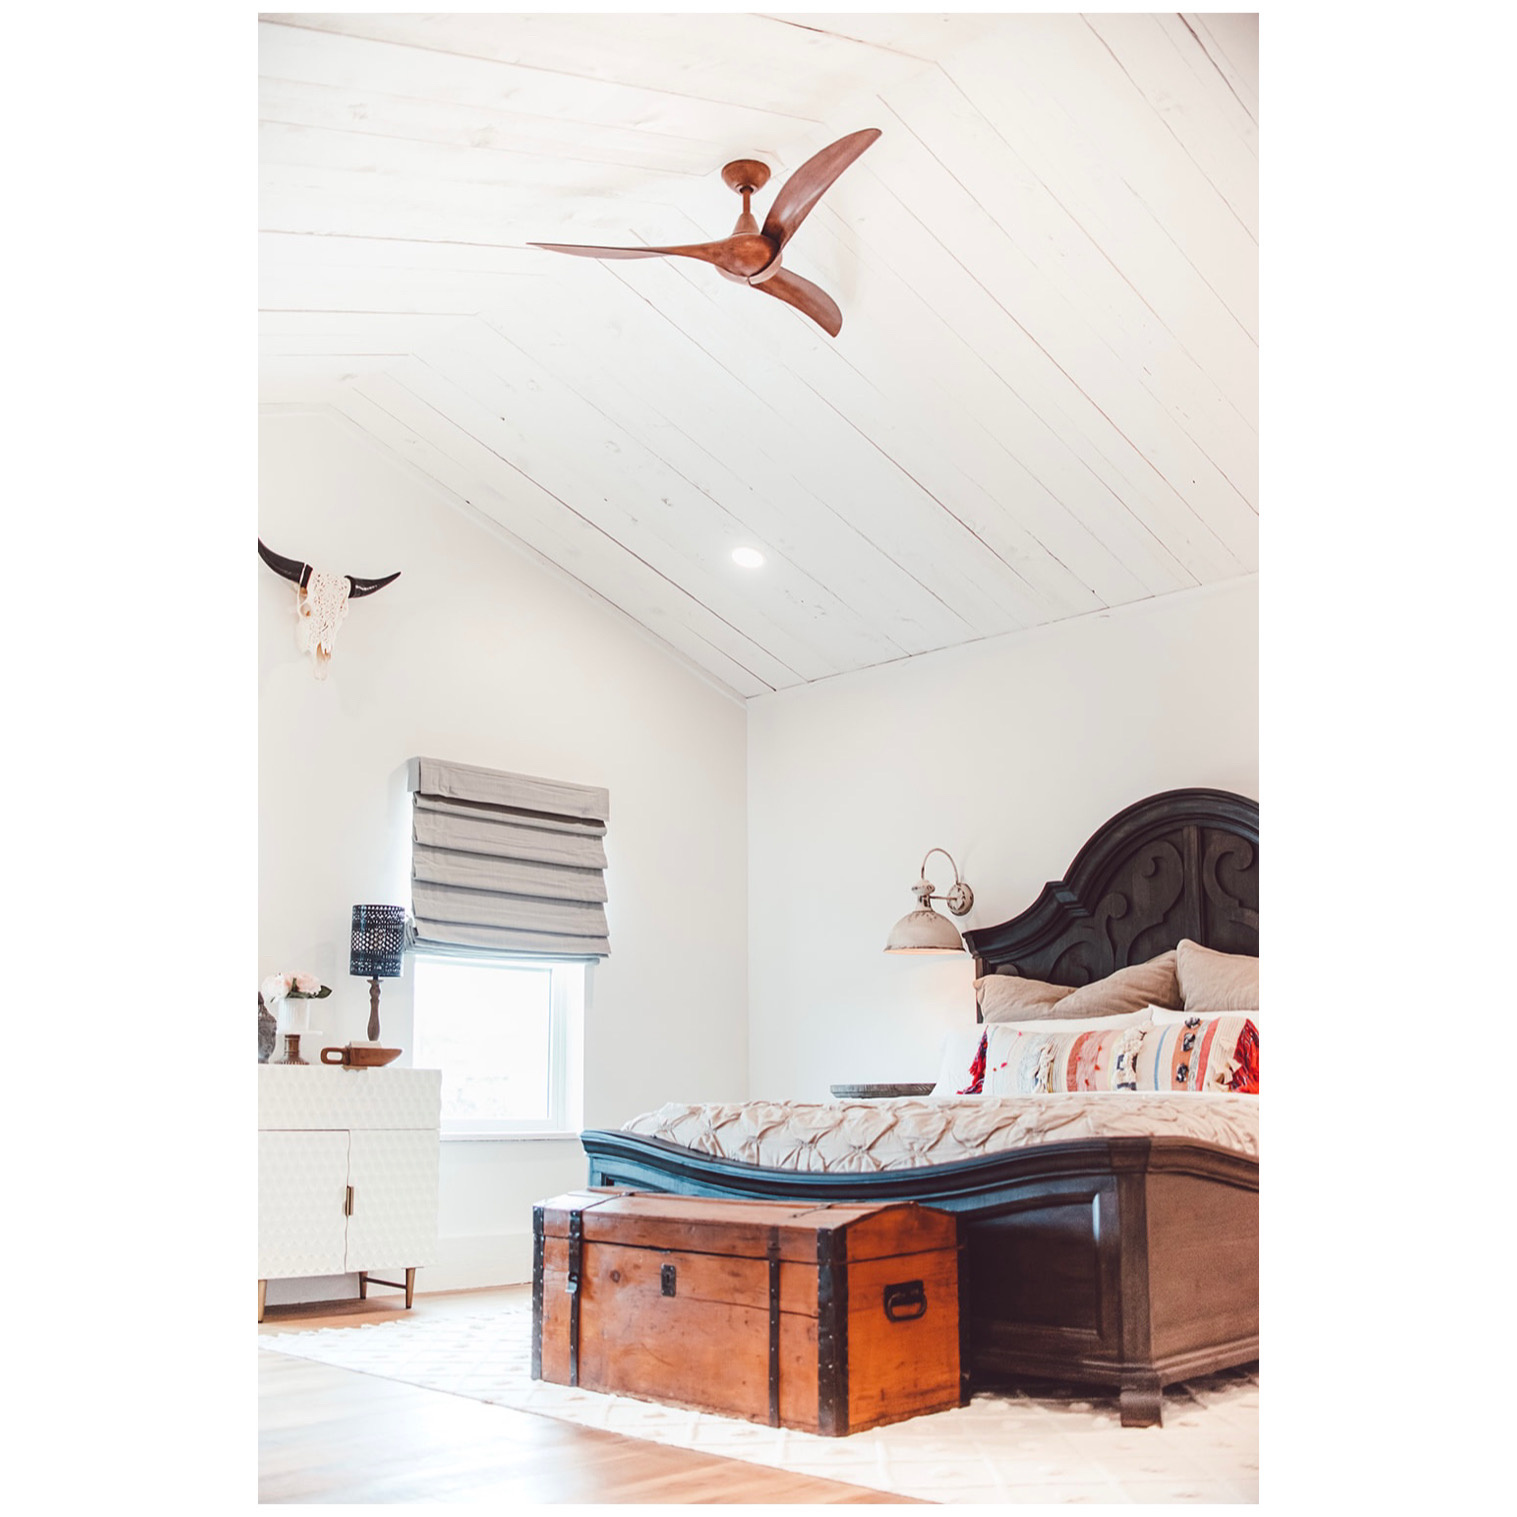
[258,1288,907,1505]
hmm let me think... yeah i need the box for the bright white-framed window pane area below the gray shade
[414,954,584,1138]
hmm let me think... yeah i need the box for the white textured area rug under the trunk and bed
[258,1305,1259,1502]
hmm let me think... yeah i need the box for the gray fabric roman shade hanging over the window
[408,759,611,959]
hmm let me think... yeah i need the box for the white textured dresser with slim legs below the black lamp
[258,1063,443,1321]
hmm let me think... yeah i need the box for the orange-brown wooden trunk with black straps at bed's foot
[532,1189,965,1435]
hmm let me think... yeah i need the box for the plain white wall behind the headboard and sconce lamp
[748,576,1259,1098]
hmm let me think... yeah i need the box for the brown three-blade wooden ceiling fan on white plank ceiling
[526,126,880,337]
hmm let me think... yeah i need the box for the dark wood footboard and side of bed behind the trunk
[583,1132,1259,1426]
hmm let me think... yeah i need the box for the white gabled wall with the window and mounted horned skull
[266,411,746,1303]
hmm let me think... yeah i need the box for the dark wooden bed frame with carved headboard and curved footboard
[583,789,1259,1427]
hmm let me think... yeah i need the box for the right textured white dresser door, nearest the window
[346,1129,437,1271]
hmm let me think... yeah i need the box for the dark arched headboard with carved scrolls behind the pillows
[963,790,1259,985]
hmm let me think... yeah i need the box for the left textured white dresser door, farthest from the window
[258,1132,348,1280]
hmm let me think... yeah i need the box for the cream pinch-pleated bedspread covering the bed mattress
[623,1091,1259,1173]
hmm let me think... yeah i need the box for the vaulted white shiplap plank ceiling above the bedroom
[259,14,1258,696]
